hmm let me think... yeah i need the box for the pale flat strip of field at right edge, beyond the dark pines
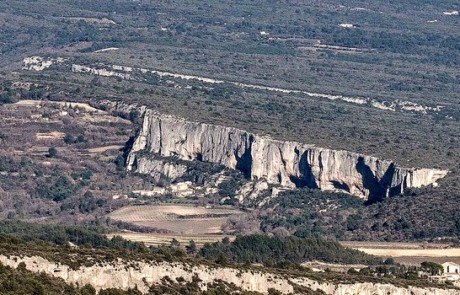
[341,242,460,265]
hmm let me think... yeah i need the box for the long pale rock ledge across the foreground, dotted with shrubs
[0,255,460,295]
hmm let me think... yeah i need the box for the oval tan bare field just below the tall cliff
[109,205,243,238]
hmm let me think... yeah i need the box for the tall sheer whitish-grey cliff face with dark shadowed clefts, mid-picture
[127,110,448,199]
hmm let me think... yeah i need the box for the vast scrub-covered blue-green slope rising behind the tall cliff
[0,0,459,169]
